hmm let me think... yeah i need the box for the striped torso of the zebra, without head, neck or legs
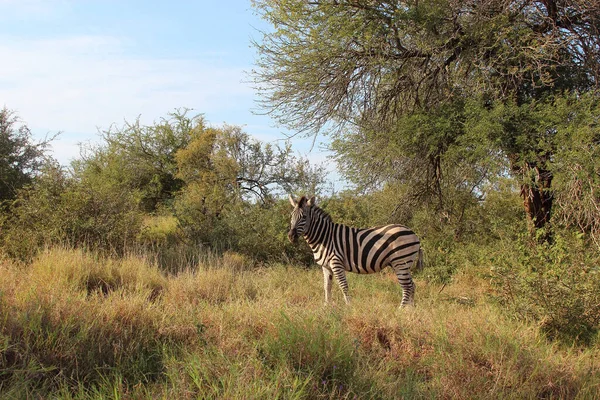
[334,224,420,274]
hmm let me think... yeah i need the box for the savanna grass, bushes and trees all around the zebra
[0,0,600,399]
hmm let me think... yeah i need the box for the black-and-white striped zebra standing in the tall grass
[288,195,423,307]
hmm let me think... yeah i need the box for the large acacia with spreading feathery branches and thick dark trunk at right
[254,0,600,228]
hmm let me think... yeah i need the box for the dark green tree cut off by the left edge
[0,107,50,203]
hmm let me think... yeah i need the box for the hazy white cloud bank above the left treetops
[0,34,253,159]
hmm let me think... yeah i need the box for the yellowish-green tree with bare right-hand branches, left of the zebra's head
[175,125,323,243]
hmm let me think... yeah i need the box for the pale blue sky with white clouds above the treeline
[0,0,333,183]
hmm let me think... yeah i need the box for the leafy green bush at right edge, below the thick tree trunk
[491,232,600,344]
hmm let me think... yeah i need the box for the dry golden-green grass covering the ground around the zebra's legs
[0,249,600,399]
